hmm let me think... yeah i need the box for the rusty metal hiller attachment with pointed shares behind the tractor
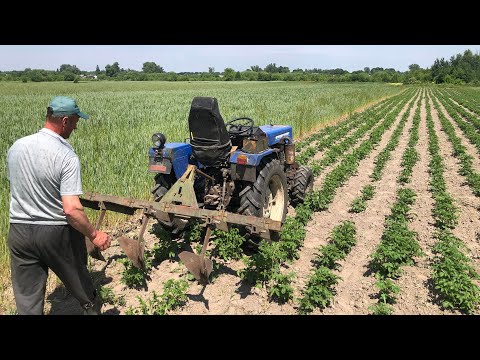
[80,165,282,283]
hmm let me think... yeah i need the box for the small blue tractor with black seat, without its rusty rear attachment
[149,97,313,237]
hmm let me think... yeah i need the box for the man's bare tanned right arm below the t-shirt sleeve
[62,195,111,250]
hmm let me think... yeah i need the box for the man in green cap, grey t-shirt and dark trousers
[7,96,111,315]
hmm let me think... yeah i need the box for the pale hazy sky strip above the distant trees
[0,45,480,73]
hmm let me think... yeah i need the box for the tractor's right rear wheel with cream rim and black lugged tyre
[238,160,288,222]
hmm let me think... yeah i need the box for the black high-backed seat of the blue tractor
[188,97,232,166]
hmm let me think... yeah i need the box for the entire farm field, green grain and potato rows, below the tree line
[0,83,480,315]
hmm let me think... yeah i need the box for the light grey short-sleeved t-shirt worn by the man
[7,128,82,225]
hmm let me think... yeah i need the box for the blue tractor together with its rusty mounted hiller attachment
[80,97,313,283]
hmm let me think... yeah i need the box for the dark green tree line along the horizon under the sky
[0,50,480,85]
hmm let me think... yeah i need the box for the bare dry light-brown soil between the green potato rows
[46,90,480,315]
